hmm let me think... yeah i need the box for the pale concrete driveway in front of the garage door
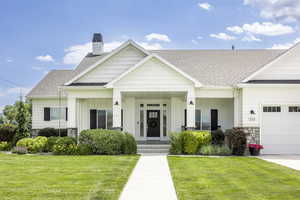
[258,155,300,170]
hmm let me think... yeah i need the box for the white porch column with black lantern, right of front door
[186,89,196,130]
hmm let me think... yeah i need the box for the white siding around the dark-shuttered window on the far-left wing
[32,99,67,129]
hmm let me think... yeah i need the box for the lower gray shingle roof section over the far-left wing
[27,70,74,98]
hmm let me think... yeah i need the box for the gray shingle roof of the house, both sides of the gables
[27,49,285,97]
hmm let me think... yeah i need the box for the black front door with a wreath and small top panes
[147,110,160,137]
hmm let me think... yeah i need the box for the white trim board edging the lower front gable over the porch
[105,54,202,88]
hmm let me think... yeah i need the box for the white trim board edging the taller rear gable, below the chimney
[64,40,150,86]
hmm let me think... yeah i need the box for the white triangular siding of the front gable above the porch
[115,58,193,88]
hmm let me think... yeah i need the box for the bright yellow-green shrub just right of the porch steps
[182,131,211,154]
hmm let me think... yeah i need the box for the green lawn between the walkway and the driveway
[168,156,300,200]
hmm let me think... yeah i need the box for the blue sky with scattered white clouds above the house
[0,0,300,112]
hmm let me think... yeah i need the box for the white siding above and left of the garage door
[242,86,300,127]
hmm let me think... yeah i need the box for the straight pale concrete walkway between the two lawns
[120,155,177,200]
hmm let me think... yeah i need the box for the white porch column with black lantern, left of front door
[112,89,122,130]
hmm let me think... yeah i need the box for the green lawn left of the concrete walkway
[0,154,139,200]
